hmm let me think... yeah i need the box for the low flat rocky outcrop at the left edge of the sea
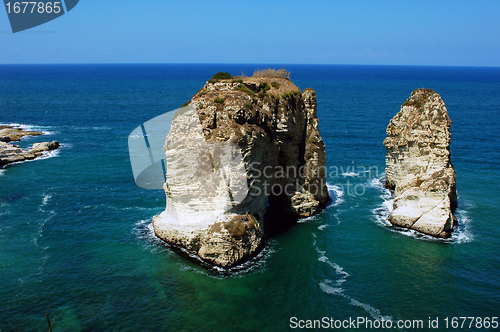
[0,126,59,167]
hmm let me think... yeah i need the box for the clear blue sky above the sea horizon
[0,0,500,66]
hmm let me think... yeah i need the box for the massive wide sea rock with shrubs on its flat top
[153,77,329,267]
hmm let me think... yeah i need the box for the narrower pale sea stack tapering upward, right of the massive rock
[384,89,457,238]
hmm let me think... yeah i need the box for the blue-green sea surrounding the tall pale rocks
[0,64,500,332]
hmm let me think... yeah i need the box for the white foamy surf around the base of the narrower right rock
[369,177,474,244]
